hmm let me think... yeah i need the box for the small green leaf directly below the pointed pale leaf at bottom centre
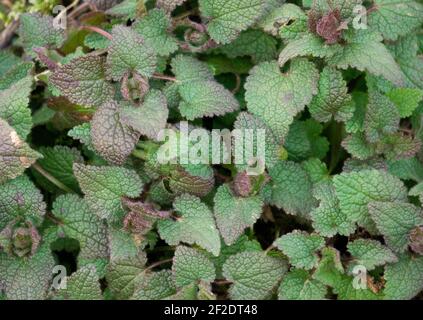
[172,246,216,287]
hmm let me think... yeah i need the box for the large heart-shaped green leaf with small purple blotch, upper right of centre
[245,59,319,141]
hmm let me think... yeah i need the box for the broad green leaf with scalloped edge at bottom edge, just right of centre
[223,252,287,300]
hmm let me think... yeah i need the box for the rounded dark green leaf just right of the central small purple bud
[269,161,315,216]
